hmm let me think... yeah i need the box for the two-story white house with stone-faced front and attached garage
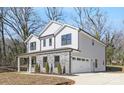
[18,21,105,74]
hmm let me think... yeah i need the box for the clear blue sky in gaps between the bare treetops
[35,7,124,30]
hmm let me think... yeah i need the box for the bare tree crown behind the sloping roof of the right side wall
[73,7,107,40]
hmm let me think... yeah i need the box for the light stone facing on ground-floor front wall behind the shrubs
[37,52,69,73]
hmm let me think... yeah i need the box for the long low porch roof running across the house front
[17,48,79,58]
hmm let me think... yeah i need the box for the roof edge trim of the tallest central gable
[39,20,63,37]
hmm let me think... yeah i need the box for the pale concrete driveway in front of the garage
[63,72,124,85]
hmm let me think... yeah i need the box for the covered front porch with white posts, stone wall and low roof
[18,48,72,73]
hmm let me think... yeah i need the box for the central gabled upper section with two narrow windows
[39,21,63,51]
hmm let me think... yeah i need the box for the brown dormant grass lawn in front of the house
[0,72,74,85]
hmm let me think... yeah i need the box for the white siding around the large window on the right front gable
[55,27,78,49]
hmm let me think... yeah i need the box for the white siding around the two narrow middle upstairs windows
[41,37,54,51]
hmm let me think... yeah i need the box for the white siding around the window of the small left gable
[27,36,40,53]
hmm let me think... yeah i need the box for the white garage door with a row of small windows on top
[71,58,91,73]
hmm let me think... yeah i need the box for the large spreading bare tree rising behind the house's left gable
[4,7,41,52]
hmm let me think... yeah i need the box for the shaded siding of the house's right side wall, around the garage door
[72,32,105,72]
